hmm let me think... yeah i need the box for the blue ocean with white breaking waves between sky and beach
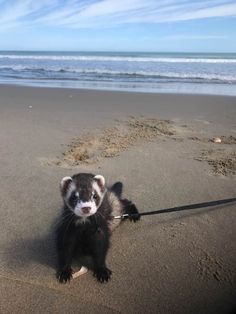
[0,51,236,95]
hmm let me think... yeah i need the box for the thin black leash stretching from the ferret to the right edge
[113,197,236,219]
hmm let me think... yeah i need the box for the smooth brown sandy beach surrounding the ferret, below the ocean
[0,85,236,314]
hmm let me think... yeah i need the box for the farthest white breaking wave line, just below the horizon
[0,54,236,64]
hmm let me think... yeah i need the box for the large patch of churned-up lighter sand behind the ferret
[43,117,175,167]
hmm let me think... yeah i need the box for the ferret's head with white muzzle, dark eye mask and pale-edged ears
[60,173,106,218]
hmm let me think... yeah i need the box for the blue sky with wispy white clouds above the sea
[0,0,236,52]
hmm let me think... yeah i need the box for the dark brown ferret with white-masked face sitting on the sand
[56,173,140,283]
